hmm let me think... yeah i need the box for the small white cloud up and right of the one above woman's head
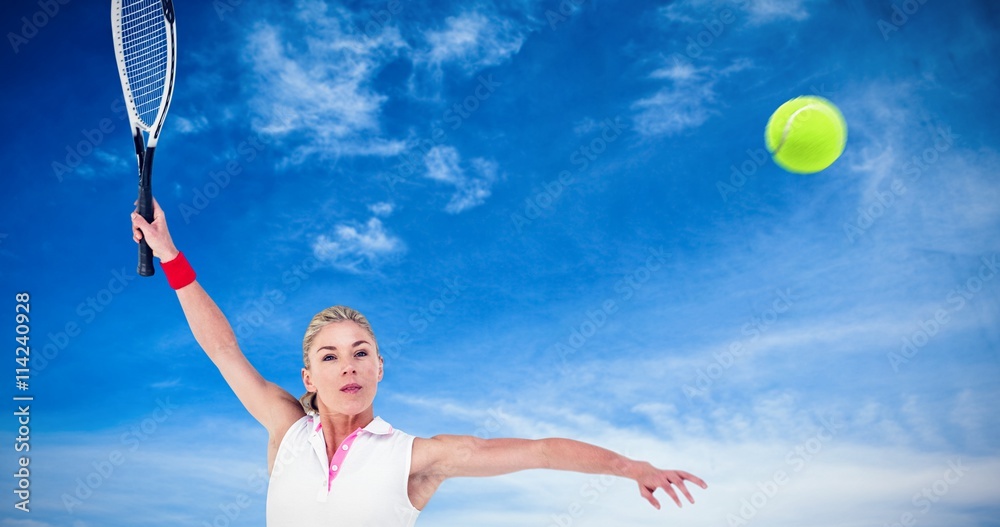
[424,145,497,214]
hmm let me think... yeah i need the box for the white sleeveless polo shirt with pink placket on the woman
[267,415,420,527]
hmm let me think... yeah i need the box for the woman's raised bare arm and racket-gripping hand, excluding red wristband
[132,200,305,440]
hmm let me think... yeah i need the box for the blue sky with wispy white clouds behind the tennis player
[0,0,1000,527]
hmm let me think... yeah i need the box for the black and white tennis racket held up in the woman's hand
[111,0,177,276]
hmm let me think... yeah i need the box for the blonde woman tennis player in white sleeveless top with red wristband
[132,200,707,527]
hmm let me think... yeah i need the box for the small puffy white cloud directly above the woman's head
[312,218,406,272]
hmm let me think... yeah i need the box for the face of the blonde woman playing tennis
[302,321,382,415]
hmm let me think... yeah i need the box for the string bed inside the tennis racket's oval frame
[121,0,167,126]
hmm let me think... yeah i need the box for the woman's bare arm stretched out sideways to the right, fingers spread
[411,435,708,509]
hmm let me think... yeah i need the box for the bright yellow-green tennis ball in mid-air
[764,95,847,174]
